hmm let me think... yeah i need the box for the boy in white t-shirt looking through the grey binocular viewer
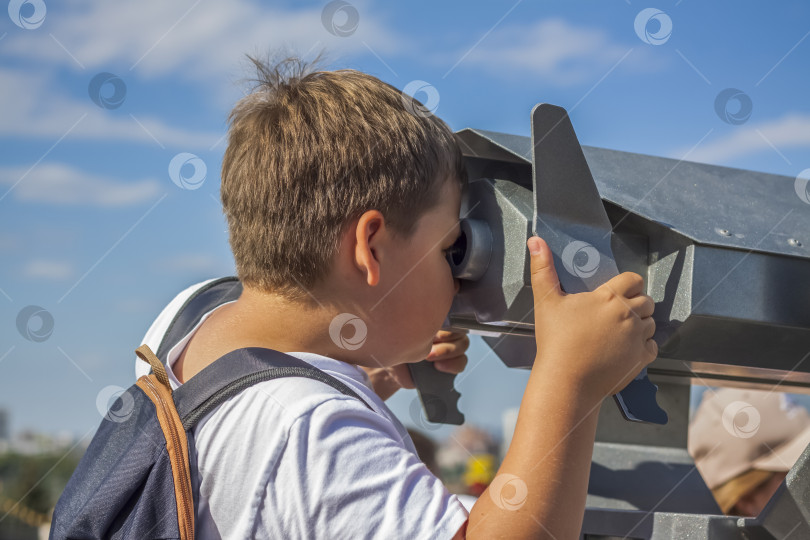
[139,59,657,538]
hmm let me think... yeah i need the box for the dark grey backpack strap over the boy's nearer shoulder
[173,347,374,431]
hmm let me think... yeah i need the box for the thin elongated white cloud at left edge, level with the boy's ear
[0,163,161,207]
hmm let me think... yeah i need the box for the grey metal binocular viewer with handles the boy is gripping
[411,104,810,425]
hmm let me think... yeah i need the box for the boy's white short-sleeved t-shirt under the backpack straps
[135,282,468,539]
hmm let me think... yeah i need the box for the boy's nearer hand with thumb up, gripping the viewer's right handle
[528,238,658,403]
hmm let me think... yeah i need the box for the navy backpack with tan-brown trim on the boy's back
[50,277,371,540]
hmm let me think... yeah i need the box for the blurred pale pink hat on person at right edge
[688,388,810,490]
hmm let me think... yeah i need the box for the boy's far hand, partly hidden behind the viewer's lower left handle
[363,330,470,400]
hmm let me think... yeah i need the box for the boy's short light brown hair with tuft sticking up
[221,57,466,299]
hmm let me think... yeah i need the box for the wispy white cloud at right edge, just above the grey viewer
[670,112,810,163]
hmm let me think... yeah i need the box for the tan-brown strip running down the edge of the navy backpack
[136,376,194,540]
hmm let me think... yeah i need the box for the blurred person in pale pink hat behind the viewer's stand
[688,388,810,517]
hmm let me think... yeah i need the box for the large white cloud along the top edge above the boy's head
[3,0,403,81]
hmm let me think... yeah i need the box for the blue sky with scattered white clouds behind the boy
[0,0,810,442]
